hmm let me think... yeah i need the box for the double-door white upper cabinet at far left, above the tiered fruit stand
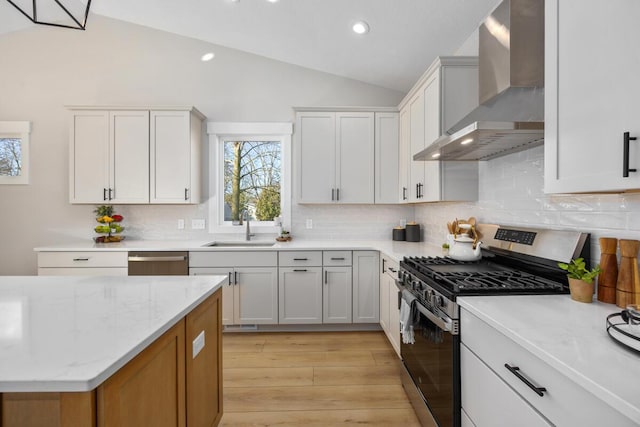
[69,110,149,203]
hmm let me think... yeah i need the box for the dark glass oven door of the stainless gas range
[400,301,460,427]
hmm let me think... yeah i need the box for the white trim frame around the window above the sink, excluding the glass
[207,122,293,235]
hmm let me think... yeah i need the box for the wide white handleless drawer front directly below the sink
[189,251,278,267]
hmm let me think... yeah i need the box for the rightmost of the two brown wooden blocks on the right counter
[616,240,640,308]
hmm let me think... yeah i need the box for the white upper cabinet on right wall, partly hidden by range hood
[400,57,478,202]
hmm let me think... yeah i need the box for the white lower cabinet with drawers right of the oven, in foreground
[460,309,636,427]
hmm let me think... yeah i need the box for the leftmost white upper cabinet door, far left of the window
[69,110,109,203]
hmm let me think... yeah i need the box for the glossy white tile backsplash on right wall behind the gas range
[415,147,640,262]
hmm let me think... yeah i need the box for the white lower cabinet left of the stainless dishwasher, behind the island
[38,251,128,276]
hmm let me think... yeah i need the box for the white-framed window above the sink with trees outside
[208,123,292,233]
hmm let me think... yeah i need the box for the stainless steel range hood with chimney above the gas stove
[413,0,544,160]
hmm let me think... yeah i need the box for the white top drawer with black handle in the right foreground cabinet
[460,310,635,426]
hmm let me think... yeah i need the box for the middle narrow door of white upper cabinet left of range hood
[408,90,425,202]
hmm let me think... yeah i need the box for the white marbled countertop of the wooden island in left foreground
[0,276,227,392]
